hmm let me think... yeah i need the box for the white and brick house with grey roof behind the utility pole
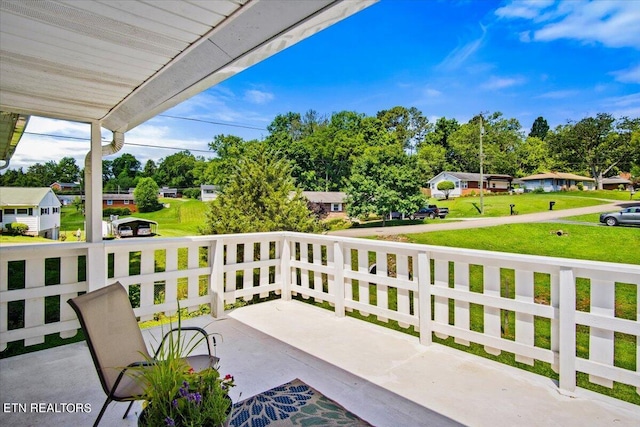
[428,171,513,199]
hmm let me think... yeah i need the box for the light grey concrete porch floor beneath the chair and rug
[0,300,640,427]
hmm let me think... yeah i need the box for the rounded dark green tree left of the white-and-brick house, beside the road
[346,144,426,225]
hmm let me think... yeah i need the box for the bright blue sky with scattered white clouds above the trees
[11,0,640,169]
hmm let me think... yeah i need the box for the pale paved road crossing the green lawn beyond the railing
[329,201,637,237]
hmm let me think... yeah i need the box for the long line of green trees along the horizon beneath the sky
[0,106,640,192]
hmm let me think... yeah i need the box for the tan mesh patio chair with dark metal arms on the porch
[67,282,219,427]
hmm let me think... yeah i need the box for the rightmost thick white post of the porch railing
[558,268,576,393]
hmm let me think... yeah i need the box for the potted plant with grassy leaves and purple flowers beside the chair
[133,310,234,427]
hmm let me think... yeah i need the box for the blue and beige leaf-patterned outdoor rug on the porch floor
[230,378,371,427]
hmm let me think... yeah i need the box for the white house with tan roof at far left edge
[0,187,60,240]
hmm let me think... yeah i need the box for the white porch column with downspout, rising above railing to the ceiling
[84,122,102,243]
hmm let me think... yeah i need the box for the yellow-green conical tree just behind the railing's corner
[200,146,318,234]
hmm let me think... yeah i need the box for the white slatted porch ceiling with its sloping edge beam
[0,0,377,160]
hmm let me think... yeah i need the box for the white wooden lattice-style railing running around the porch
[0,232,640,398]
